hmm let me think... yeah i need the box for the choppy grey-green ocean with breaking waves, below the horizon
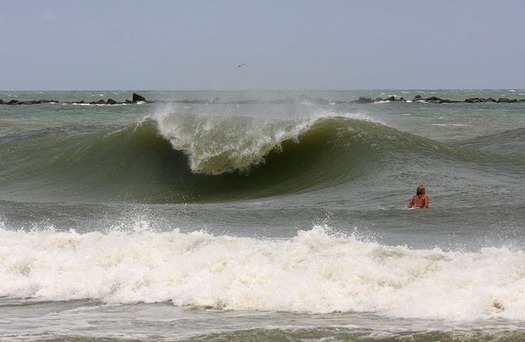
[0,89,525,341]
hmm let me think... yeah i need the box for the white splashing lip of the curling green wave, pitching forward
[155,113,314,175]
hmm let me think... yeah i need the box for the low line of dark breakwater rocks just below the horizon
[0,93,525,106]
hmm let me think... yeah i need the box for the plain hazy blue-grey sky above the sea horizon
[0,0,525,90]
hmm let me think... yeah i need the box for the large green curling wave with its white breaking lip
[0,115,516,203]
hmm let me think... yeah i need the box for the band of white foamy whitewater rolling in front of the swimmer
[0,222,525,321]
